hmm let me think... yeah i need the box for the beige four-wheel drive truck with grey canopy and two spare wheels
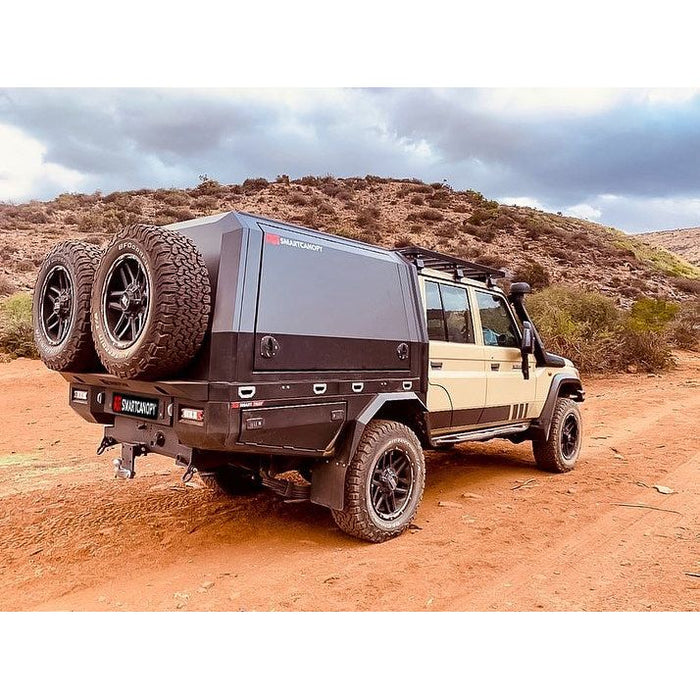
[34,212,583,542]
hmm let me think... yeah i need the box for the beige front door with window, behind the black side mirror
[474,290,538,425]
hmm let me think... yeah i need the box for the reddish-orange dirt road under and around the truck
[0,354,700,610]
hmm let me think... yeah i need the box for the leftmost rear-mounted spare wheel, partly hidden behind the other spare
[32,241,101,372]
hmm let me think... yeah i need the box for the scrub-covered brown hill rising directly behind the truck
[0,175,700,306]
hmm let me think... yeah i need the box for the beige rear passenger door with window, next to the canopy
[425,280,486,431]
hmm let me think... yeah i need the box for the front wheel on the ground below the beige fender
[532,397,583,474]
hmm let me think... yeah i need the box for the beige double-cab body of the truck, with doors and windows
[420,270,579,435]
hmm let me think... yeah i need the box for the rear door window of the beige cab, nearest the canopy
[425,282,474,343]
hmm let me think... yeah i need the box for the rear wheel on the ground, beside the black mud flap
[331,420,425,542]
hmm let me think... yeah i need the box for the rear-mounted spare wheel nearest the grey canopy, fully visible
[91,224,211,380]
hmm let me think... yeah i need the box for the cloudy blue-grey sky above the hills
[0,88,700,232]
